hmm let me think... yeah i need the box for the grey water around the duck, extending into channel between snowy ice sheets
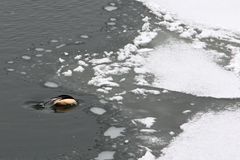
[0,0,238,160]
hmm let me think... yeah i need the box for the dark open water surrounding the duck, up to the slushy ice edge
[0,0,152,160]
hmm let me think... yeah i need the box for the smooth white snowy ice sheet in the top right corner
[140,0,240,31]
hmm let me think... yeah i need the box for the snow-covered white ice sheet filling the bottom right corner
[157,110,240,160]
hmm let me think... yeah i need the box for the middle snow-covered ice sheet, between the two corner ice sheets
[144,41,240,98]
